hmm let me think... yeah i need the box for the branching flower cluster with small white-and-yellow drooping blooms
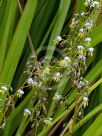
[0,0,99,135]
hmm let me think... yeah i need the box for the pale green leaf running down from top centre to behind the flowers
[46,0,71,64]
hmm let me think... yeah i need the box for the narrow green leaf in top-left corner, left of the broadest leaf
[0,0,17,71]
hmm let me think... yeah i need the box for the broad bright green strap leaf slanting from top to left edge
[0,0,38,84]
